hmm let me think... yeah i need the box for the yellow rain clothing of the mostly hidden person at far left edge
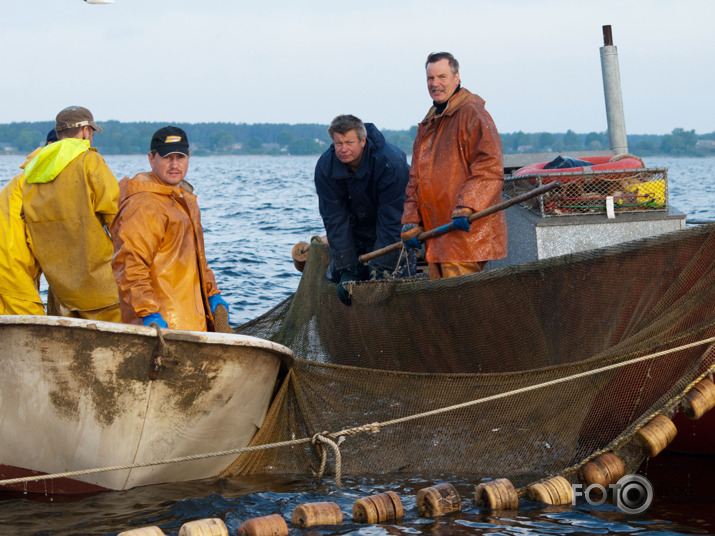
[0,147,45,315]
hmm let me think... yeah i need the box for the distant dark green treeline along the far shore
[0,121,715,156]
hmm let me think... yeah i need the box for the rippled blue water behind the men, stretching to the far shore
[0,156,715,325]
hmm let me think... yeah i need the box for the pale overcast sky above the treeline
[0,0,715,134]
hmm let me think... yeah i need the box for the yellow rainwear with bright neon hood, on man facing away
[23,138,119,314]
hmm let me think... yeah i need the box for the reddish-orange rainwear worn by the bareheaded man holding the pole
[402,88,507,263]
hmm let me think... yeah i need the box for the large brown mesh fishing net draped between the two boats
[225,225,715,485]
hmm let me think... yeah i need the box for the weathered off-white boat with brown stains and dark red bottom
[0,316,293,494]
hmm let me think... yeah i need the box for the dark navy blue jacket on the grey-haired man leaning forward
[315,123,410,282]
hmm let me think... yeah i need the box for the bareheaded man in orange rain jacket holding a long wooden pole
[401,52,507,279]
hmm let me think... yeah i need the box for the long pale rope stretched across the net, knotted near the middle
[0,337,715,486]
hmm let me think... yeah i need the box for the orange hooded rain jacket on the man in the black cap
[111,173,219,331]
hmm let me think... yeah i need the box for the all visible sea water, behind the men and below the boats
[0,156,715,536]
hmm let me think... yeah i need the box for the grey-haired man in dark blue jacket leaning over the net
[315,115,415,305]
